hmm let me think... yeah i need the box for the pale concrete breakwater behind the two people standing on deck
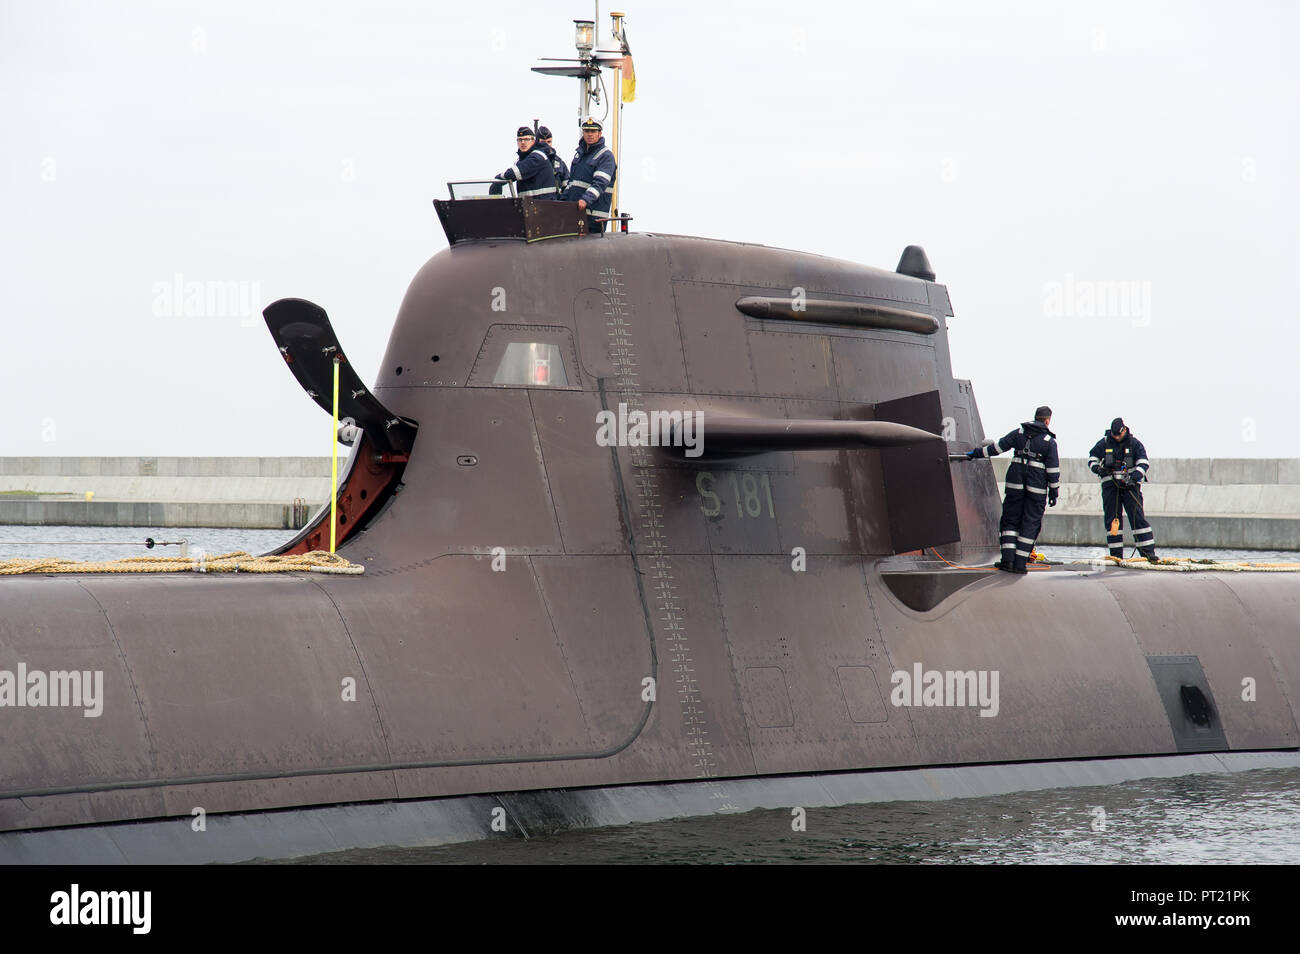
[993,456,1300,551]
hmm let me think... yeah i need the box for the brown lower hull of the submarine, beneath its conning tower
[0,566,1300,831]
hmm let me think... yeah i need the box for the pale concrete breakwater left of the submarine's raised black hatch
[0,458,330,530]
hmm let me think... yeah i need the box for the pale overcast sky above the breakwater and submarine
[0,0,1300,462]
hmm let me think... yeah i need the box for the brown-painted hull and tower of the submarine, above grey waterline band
[0,235,1300,831]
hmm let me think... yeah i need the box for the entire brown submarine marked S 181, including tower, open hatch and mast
[0,14,1300,862]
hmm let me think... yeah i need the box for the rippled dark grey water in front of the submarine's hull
[289,768,1300,864]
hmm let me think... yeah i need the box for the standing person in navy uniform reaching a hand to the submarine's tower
[966,406,1061,573]
